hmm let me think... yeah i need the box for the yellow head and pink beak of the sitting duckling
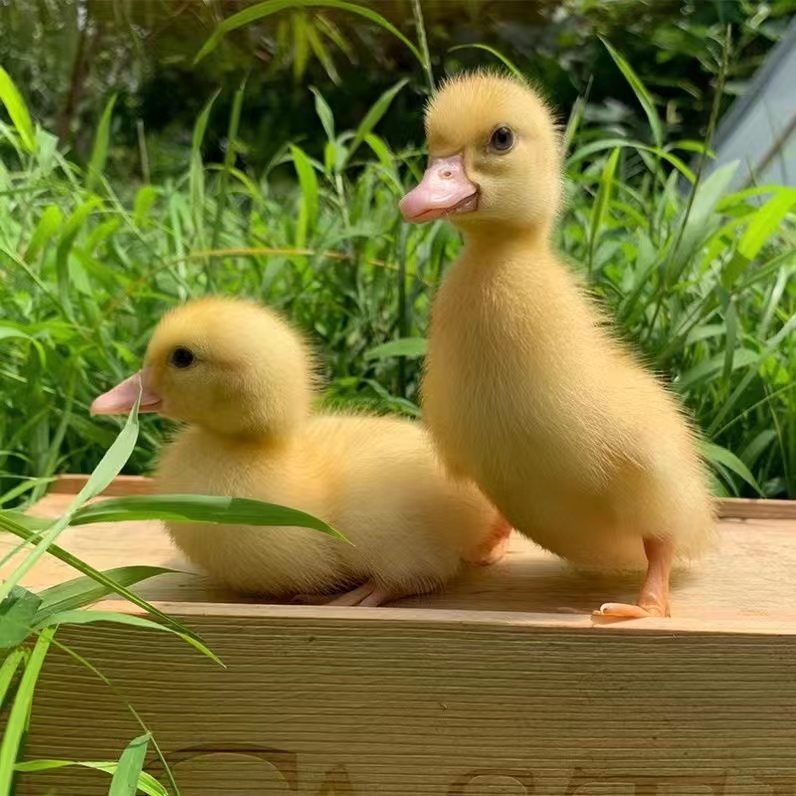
[91,298,314,436]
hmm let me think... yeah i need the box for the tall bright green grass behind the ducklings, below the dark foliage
[0,68,796,504]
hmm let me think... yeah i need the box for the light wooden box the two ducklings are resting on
[0,479,796,796]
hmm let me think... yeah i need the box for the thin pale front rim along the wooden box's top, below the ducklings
[89,598,796,637]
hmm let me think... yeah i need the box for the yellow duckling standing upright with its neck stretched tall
[400,73,715,618]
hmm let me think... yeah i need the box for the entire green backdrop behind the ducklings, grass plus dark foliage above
[0,0,796,503]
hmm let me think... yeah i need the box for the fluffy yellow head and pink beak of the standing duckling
[400,72,562,233]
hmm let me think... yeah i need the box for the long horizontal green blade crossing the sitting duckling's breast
[72,495,345,540]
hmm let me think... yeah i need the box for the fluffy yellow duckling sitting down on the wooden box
[91,298,507,606]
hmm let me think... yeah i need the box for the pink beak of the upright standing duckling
[399,155,478,224]
